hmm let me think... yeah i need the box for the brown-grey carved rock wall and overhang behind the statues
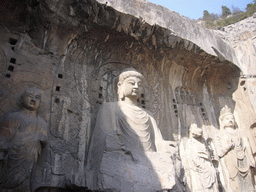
[0,0,255,190]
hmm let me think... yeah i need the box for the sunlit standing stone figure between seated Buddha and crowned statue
[186,124,218,192]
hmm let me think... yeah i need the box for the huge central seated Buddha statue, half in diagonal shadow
[86,69,181,191]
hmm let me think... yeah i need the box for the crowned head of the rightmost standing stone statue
[219,105,235,130]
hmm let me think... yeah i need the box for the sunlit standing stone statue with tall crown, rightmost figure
[215,106,255,192]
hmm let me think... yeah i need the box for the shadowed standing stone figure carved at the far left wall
[0,88,47,192]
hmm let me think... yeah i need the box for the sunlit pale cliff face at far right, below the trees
[213,14,256,117]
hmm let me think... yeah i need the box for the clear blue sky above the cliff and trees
[148,0,253,19]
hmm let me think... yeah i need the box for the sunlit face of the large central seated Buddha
[120,76,142,99]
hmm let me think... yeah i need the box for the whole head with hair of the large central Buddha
[117,68,143,101]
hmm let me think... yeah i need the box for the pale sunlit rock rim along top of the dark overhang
[97,0,240,66]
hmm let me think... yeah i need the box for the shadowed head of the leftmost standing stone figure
[21,88,41,111]
